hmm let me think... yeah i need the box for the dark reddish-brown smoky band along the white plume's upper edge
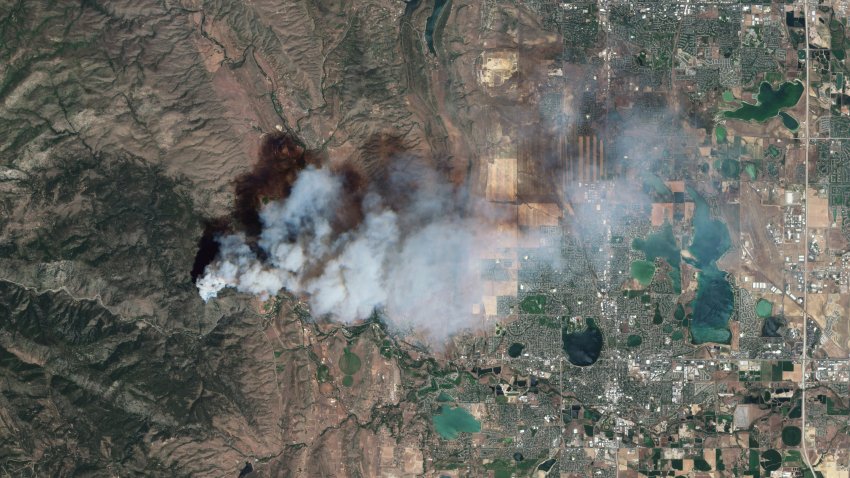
[191,131,445,281]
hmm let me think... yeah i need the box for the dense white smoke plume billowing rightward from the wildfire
[197,167,490,339]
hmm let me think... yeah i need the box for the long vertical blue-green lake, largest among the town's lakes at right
[687,187,735,344]
